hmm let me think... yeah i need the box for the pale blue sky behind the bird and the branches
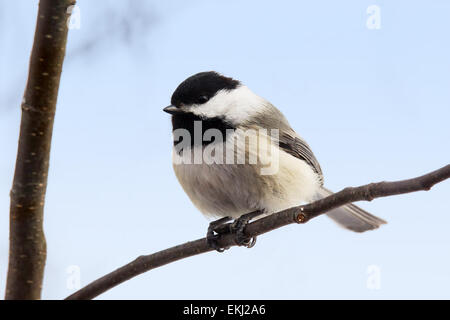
[0,0,450,299]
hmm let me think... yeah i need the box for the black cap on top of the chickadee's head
[171,71,240,107]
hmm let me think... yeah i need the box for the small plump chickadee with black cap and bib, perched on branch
[164,71,386,251]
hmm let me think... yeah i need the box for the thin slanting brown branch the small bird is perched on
[66,164,450,300]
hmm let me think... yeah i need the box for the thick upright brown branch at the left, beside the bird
[5,0,75,299]
